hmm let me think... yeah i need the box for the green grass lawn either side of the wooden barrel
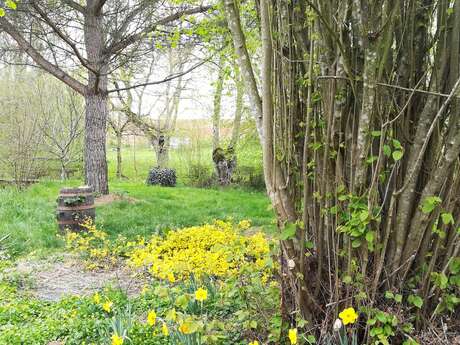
[0,181,273,256]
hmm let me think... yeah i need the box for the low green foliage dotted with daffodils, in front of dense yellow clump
[0,222,280,345]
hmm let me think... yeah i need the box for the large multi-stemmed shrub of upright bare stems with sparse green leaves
[228,0,460,344]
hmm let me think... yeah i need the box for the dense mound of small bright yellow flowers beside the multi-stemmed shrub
[128,221,270,282]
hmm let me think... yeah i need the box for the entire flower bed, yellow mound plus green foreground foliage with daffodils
[0,220,279,344]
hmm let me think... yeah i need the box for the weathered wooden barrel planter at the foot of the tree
[57,186,96,232]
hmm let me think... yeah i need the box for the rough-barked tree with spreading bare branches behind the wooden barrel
[0,0,210,193]
